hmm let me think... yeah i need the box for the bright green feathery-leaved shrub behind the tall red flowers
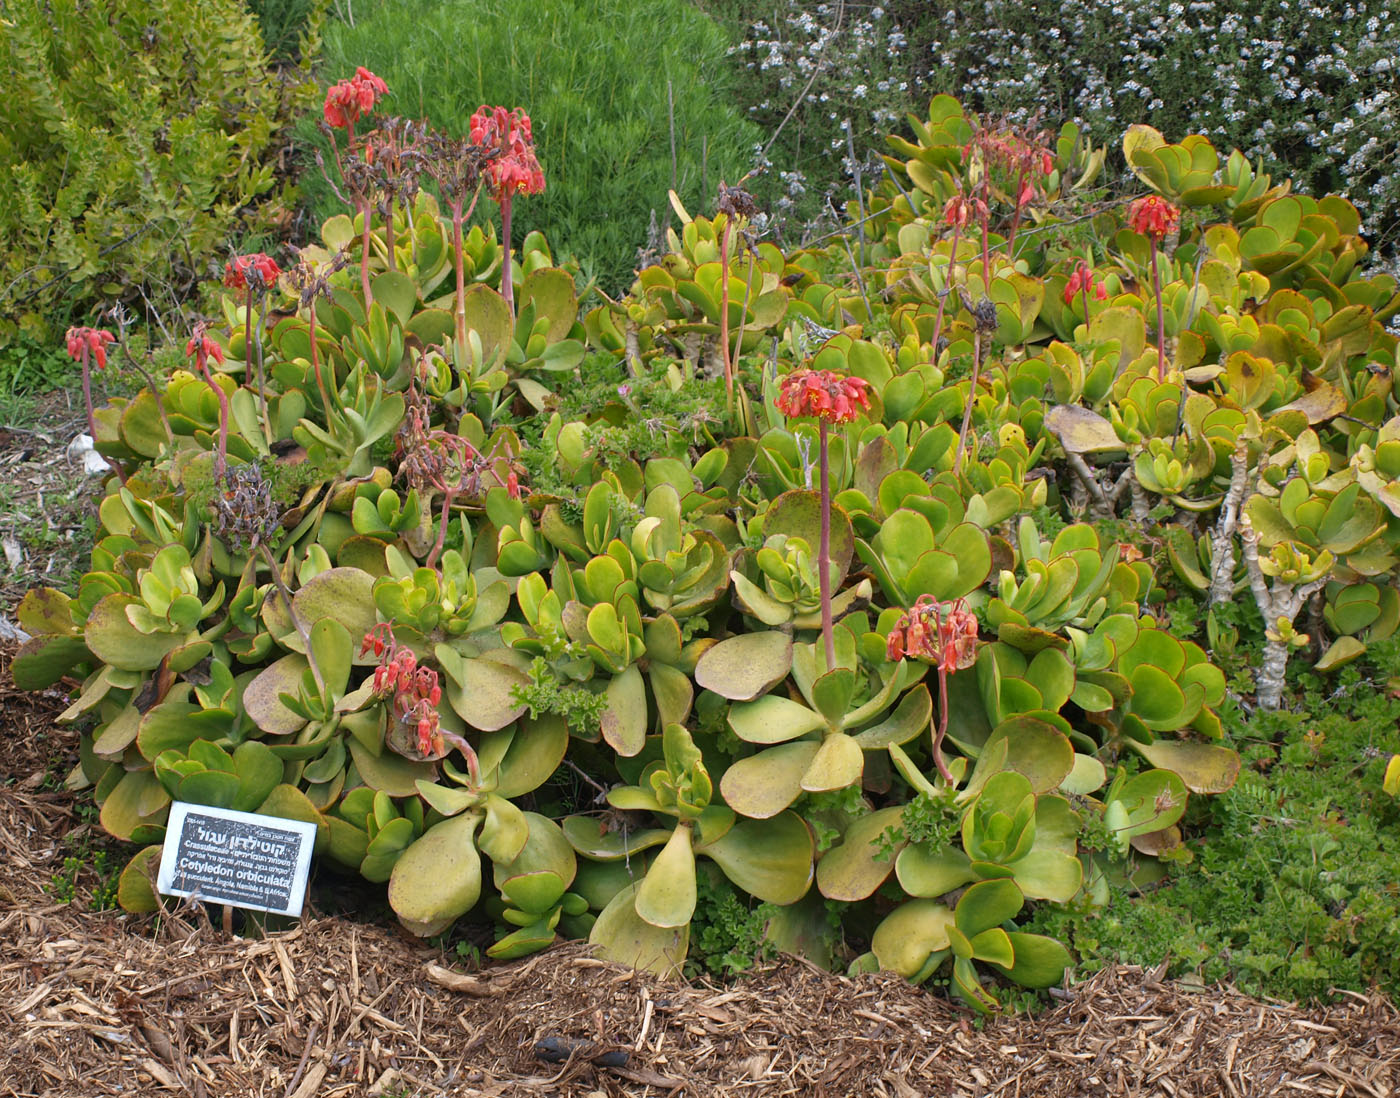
[304,0,757,289]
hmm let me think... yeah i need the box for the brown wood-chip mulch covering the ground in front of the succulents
[0,648,1400,1098]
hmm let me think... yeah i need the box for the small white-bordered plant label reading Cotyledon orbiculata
[155,801,316,916]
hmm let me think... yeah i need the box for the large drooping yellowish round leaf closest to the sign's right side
[389,812,482,926]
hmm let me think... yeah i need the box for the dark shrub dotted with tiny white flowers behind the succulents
[696,0,1400,266]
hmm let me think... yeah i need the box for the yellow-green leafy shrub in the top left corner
[0,0,303,340]
